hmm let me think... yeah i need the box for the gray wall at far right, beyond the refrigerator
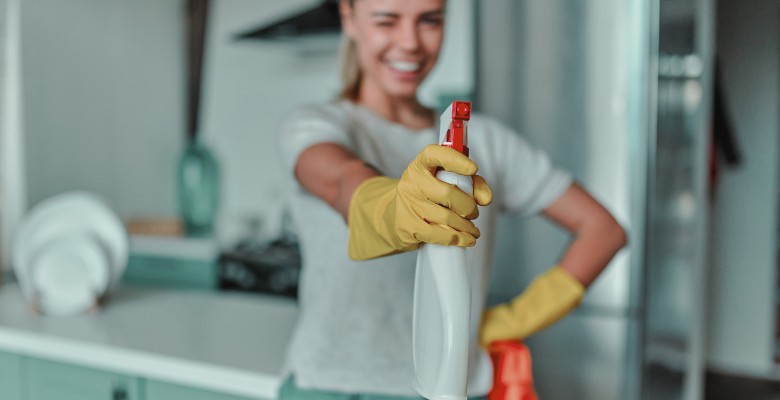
[708,0,780,378]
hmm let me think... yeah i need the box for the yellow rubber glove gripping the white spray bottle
[348,145,493,260]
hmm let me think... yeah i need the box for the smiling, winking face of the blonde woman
[342,0,446,98]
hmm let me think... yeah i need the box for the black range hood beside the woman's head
[235,0,341,42]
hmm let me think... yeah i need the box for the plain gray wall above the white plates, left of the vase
[22,0,185,222]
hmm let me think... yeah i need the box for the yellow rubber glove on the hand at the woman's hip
[480,266,585,347]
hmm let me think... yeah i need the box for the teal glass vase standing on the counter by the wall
[176,138,220,236]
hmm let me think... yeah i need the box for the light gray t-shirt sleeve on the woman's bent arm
[488,119,572,215]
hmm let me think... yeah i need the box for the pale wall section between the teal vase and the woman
[201,0,339,244]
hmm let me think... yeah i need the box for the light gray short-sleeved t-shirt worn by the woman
[281,100,571,396]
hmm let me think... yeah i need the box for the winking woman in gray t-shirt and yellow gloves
[280,0,626,399]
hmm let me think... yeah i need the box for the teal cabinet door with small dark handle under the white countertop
[27,358,140,400]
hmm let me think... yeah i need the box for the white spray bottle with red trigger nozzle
[412,101,473,400]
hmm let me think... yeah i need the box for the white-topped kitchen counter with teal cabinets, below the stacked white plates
[0,285,297,400]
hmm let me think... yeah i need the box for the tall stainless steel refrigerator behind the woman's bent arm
[475,0,714,400]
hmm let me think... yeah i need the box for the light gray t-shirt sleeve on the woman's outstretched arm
[280,104,352,179]
